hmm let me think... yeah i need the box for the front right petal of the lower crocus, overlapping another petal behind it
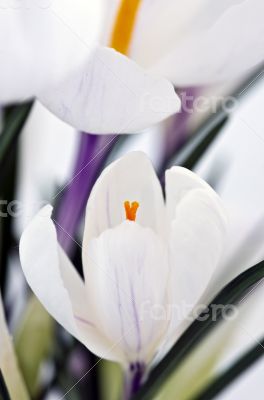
[170,189,225,307]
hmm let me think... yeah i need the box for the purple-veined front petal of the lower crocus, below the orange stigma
[83,221,168,363]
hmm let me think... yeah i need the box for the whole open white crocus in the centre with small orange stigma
[20,152,225,390]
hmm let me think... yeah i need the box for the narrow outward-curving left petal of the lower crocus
[20,206,78,337]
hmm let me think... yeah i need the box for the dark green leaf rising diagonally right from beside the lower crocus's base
[133,261,264,400]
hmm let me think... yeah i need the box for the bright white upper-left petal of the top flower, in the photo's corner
[0,0,102,103]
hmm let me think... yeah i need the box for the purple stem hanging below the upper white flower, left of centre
[55,133,116,256]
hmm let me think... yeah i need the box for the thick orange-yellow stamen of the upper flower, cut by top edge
[110,0,141,55]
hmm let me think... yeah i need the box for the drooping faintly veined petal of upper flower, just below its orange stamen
[38,47,180,133]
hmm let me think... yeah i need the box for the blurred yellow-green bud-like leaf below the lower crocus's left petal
[15,295,54,397]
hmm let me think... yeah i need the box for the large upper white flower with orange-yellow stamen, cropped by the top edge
[0,0,264,133]
